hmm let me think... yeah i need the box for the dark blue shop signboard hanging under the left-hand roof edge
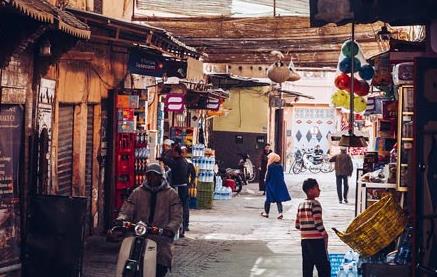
[128,49,187,78]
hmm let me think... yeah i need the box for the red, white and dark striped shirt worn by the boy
[296,199,327,239]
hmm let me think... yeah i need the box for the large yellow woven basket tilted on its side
[333,194,406,256]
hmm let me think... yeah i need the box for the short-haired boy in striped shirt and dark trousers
[296,178,331,277]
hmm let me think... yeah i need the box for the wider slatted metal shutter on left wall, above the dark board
[58,105,74,196]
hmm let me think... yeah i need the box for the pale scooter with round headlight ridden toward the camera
[109,221,173,277]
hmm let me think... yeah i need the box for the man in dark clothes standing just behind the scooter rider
[162,144,190,237]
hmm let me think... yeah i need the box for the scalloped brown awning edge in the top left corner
[5,0,91,39]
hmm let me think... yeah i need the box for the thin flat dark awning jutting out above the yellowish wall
[208,73,270,90]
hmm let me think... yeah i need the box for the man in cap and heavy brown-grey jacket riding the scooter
[116,163,182,277]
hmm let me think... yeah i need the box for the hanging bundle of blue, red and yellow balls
[331,40,375,113]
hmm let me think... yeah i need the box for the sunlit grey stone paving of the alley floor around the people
[84,169,355,277]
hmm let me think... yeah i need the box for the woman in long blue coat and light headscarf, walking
[261,152,291,219]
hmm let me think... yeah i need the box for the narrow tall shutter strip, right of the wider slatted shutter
[85,105,94,234]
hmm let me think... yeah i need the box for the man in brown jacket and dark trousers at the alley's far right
[329,147,354,204]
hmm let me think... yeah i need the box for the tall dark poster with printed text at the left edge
[0,105,23,268]
